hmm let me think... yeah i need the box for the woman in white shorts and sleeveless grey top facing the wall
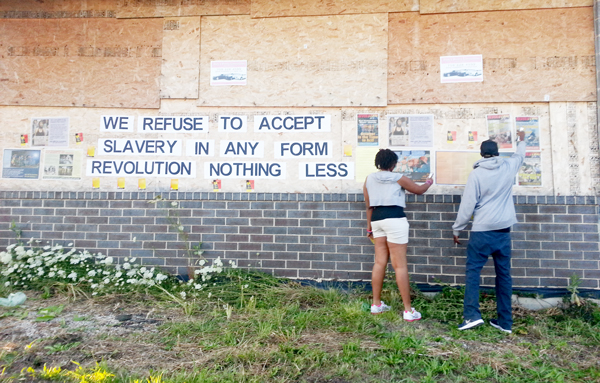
[363,149,433,322]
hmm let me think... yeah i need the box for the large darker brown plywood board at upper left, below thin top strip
[0,19,163,108]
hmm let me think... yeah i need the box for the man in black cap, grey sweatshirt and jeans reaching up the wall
[452,132,526,333]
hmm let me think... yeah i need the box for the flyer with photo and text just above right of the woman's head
[387,114,433,148]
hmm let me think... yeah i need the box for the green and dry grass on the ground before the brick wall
[0,270,600,383]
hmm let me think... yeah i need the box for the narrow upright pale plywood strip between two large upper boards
[160,17,200,98]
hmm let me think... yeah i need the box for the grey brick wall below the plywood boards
[0,191,600,289]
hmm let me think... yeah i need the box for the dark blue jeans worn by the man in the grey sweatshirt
[463,231,512,330]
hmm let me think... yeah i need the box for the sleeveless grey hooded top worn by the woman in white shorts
[367,171,406,207]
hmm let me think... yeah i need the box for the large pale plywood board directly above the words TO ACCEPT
[199,14,388,107]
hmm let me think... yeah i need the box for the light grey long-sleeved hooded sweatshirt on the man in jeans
[452,141,525,236]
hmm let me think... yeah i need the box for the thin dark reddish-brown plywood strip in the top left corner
[0,0,119,19]
